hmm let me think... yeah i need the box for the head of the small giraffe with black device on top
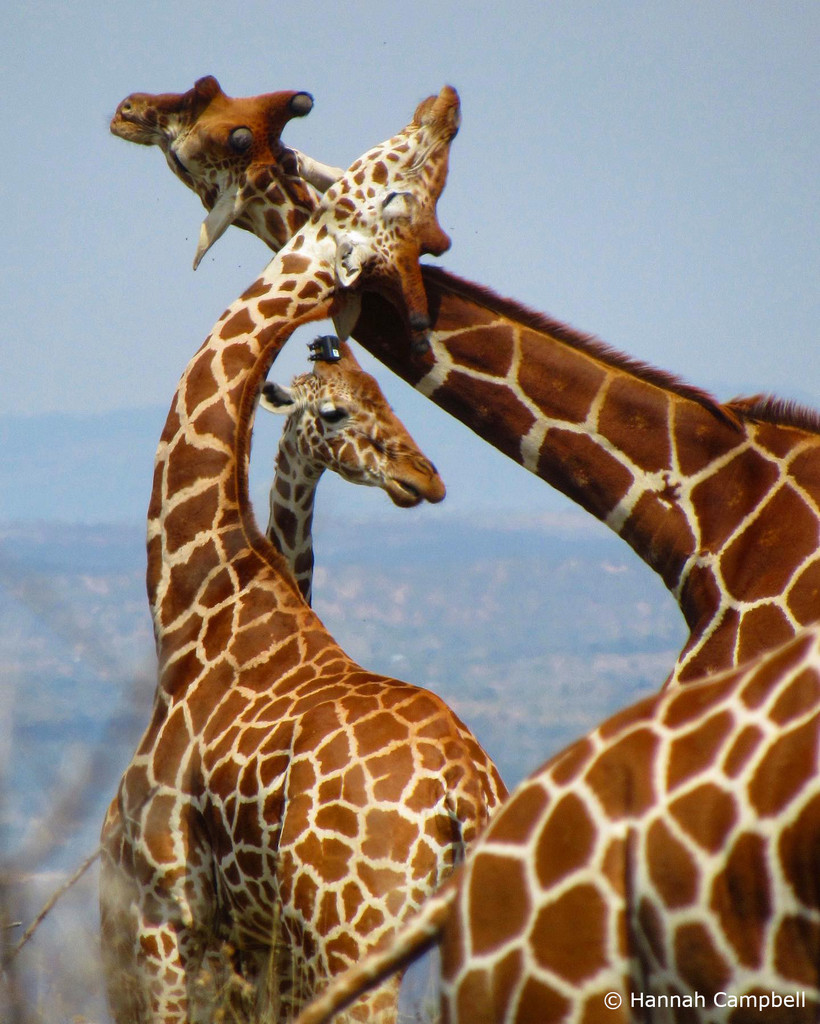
[260,338,445,508]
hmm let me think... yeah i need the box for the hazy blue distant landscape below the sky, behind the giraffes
[0,405,684,1024]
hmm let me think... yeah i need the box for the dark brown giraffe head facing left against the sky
[111,75,316,268]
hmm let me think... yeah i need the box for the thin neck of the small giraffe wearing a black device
[267,432,322,604]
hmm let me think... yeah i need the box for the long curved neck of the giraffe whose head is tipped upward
[147,247,335,689]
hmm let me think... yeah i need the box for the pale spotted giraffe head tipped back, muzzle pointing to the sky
[312,86,460,350]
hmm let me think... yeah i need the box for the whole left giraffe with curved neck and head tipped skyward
[100,87,506,1024]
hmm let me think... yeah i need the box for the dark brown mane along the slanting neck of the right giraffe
[424,265,820,432]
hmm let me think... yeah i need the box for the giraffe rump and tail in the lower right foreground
[297,625,820,1024]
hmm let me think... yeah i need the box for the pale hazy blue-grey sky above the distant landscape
[0,0,820,520]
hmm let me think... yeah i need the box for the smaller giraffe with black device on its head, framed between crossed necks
[259,335,444,604]
